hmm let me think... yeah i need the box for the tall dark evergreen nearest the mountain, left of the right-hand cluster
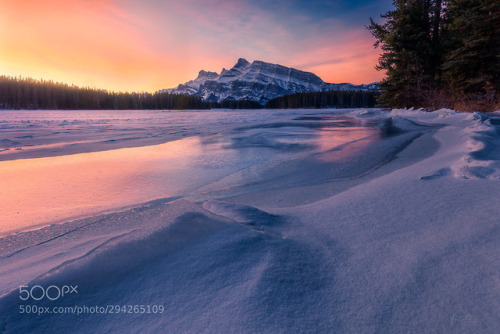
[367,0,442,107]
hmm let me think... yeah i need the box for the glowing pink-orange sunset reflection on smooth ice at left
[0,137,201,234]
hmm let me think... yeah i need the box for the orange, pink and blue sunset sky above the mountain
[0,0,392,92]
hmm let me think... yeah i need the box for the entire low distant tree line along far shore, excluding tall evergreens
[0,76,377,110]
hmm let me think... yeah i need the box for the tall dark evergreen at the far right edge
[443,0,500,105]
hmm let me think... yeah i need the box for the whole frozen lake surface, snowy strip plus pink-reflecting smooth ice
[0,110,384,234]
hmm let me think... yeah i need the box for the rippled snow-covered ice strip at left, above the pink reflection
[0,110,296,160]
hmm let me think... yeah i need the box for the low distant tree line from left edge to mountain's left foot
[0,76,210,110]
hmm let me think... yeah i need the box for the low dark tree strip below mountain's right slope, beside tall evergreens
[266,90,378,109]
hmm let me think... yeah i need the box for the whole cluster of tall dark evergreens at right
[367,0,500,111]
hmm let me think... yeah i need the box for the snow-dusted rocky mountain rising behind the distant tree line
[161,58,378,105]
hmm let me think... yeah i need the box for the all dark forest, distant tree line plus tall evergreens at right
[0,0,500,111]
